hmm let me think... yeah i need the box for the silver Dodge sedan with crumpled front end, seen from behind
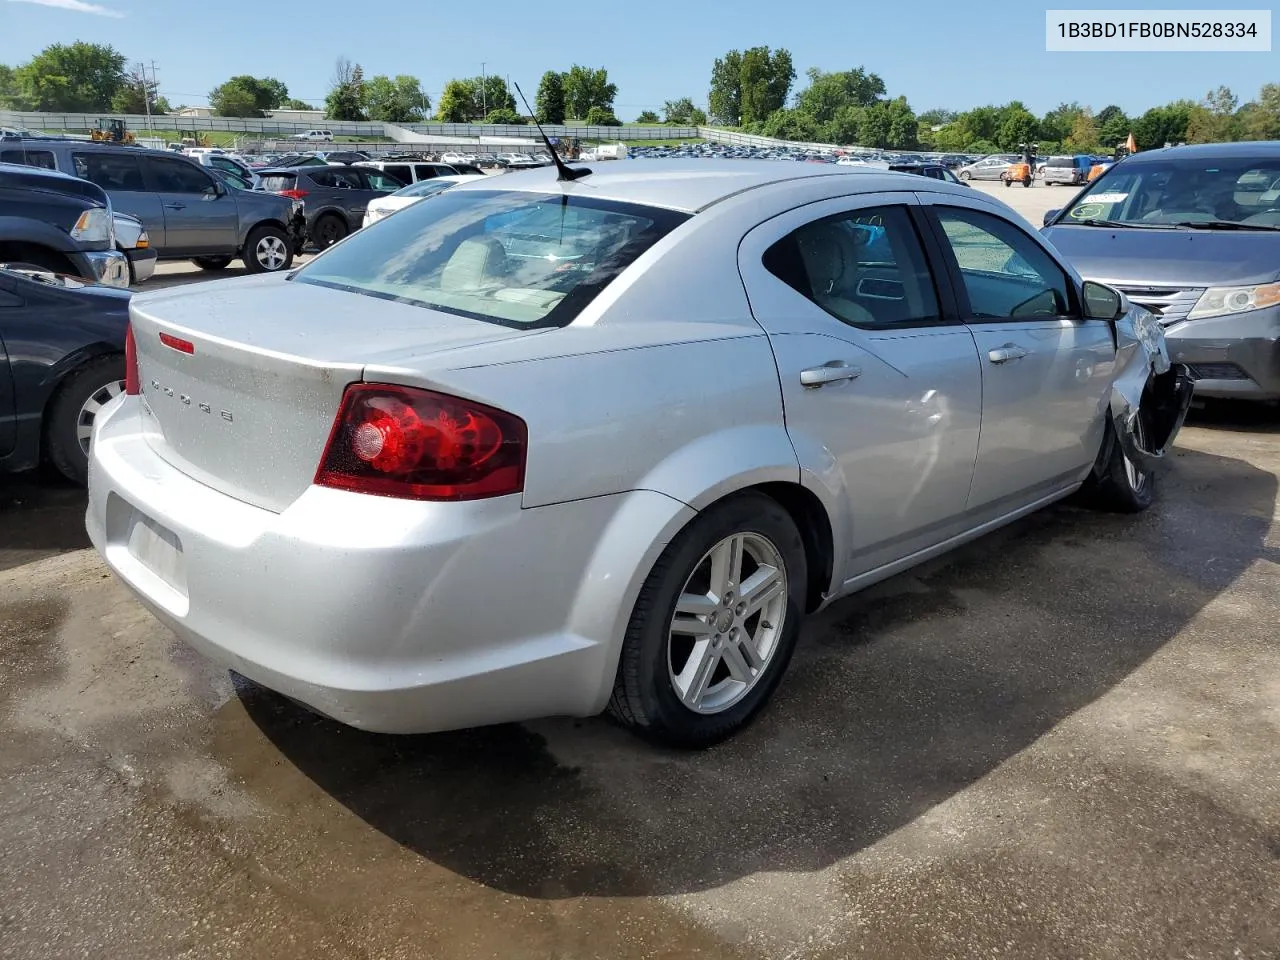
[87,160,1190,746]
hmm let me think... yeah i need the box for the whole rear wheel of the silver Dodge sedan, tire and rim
[609,493,808,748]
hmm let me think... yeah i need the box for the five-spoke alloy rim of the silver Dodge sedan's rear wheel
[667,532,788,714]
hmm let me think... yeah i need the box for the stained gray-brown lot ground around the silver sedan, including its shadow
[0,180,1280,960]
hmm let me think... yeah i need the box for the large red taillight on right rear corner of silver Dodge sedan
[315,384,529,500]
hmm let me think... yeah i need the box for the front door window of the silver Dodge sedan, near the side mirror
[934,206,1071,320]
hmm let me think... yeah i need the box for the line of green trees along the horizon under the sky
[0,41,1280,154]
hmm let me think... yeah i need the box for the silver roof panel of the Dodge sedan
[445,160,972,214]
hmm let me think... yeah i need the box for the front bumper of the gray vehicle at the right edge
[1165,307,1280,399]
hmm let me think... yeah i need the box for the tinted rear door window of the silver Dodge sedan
[764,206,940,329]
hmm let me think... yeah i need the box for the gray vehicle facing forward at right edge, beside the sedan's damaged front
[1043,142,1280,401]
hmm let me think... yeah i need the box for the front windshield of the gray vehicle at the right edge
[1059,157,1280,229]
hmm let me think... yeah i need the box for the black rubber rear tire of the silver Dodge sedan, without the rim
[609,493,808,749]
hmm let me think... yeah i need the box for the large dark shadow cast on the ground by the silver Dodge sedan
[238,448,1280,899]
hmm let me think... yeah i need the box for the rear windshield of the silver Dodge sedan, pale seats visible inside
[294,189,689,328]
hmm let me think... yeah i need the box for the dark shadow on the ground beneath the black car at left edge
[0,470,90,571]
